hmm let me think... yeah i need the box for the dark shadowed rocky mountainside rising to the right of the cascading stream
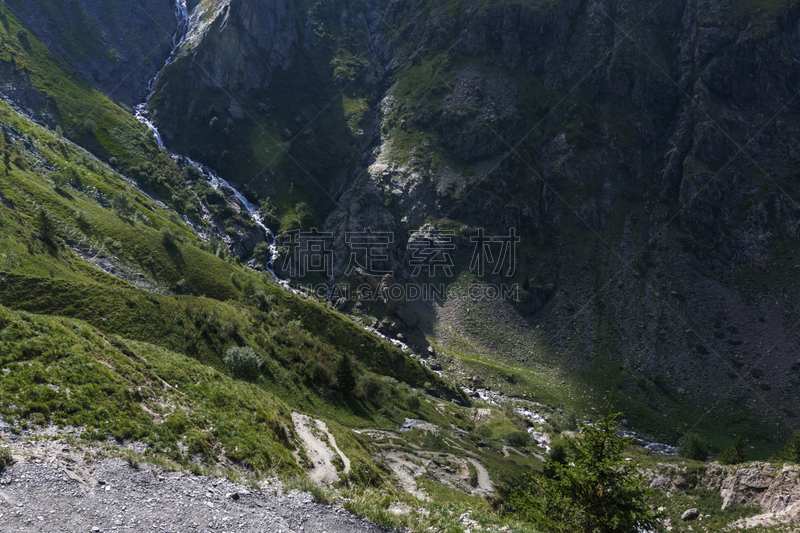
[114,0,800,447]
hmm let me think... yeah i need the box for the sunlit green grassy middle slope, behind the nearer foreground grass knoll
[0,95,458,448]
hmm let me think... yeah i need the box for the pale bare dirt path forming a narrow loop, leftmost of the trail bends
[292,413,350,485]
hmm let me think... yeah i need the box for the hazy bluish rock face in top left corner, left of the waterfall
[6,0,177,105]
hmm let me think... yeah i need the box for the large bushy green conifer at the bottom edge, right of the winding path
[511,408,659,533]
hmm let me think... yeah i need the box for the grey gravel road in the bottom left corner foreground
[0,442,386,533]
